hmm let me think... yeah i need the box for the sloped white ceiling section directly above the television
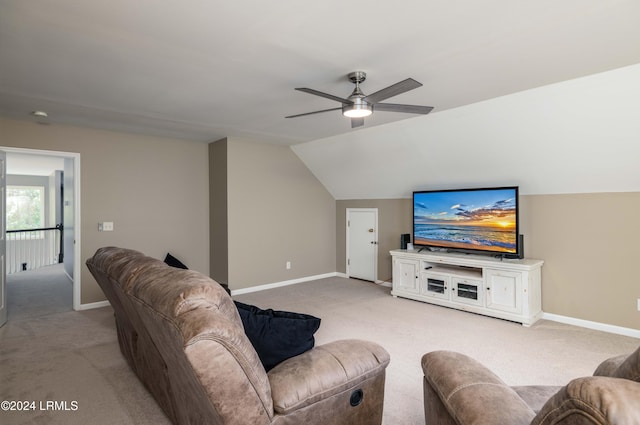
[292,64,640,199]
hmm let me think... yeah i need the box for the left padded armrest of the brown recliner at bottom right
[422,351,535,425]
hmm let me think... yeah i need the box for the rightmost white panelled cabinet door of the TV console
[484,269,522,313]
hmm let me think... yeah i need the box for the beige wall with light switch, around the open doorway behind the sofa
[0,118,209,304]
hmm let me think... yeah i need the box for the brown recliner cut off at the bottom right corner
[422,348,640,425]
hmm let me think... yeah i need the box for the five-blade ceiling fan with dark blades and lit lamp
[285,71,433,128]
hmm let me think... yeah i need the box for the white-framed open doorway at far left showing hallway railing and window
[0,147,81,320]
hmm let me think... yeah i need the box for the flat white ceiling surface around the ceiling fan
[0,0,640,145]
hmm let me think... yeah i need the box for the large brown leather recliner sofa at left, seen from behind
[87,247,389,425]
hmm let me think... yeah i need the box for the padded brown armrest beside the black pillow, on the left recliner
[268,339,389,414]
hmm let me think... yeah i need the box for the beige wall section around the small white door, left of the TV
[336,199,412,281]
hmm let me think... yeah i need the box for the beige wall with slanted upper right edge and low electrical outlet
[227,138,336,290]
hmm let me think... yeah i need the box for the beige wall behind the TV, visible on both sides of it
[336,192,640,329]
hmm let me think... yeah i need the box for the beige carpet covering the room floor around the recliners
[0,277,640,425]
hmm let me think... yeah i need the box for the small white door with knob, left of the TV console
[347,208,378,282]
